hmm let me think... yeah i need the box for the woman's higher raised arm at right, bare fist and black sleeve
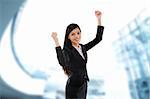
[85,10,104,51]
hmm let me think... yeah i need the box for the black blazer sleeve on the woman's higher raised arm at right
[85,26,104,51]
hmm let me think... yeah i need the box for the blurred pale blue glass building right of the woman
[114,9,150,99]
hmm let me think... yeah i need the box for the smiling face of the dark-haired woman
[68,28,81,46]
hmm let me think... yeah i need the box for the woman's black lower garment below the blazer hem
[65,79,88,99]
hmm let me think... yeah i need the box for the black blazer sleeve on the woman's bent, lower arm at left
[56,46,69,68]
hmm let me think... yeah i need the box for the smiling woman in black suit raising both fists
[51,11,104,99]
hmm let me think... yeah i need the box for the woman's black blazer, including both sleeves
[56,26,104,85]
